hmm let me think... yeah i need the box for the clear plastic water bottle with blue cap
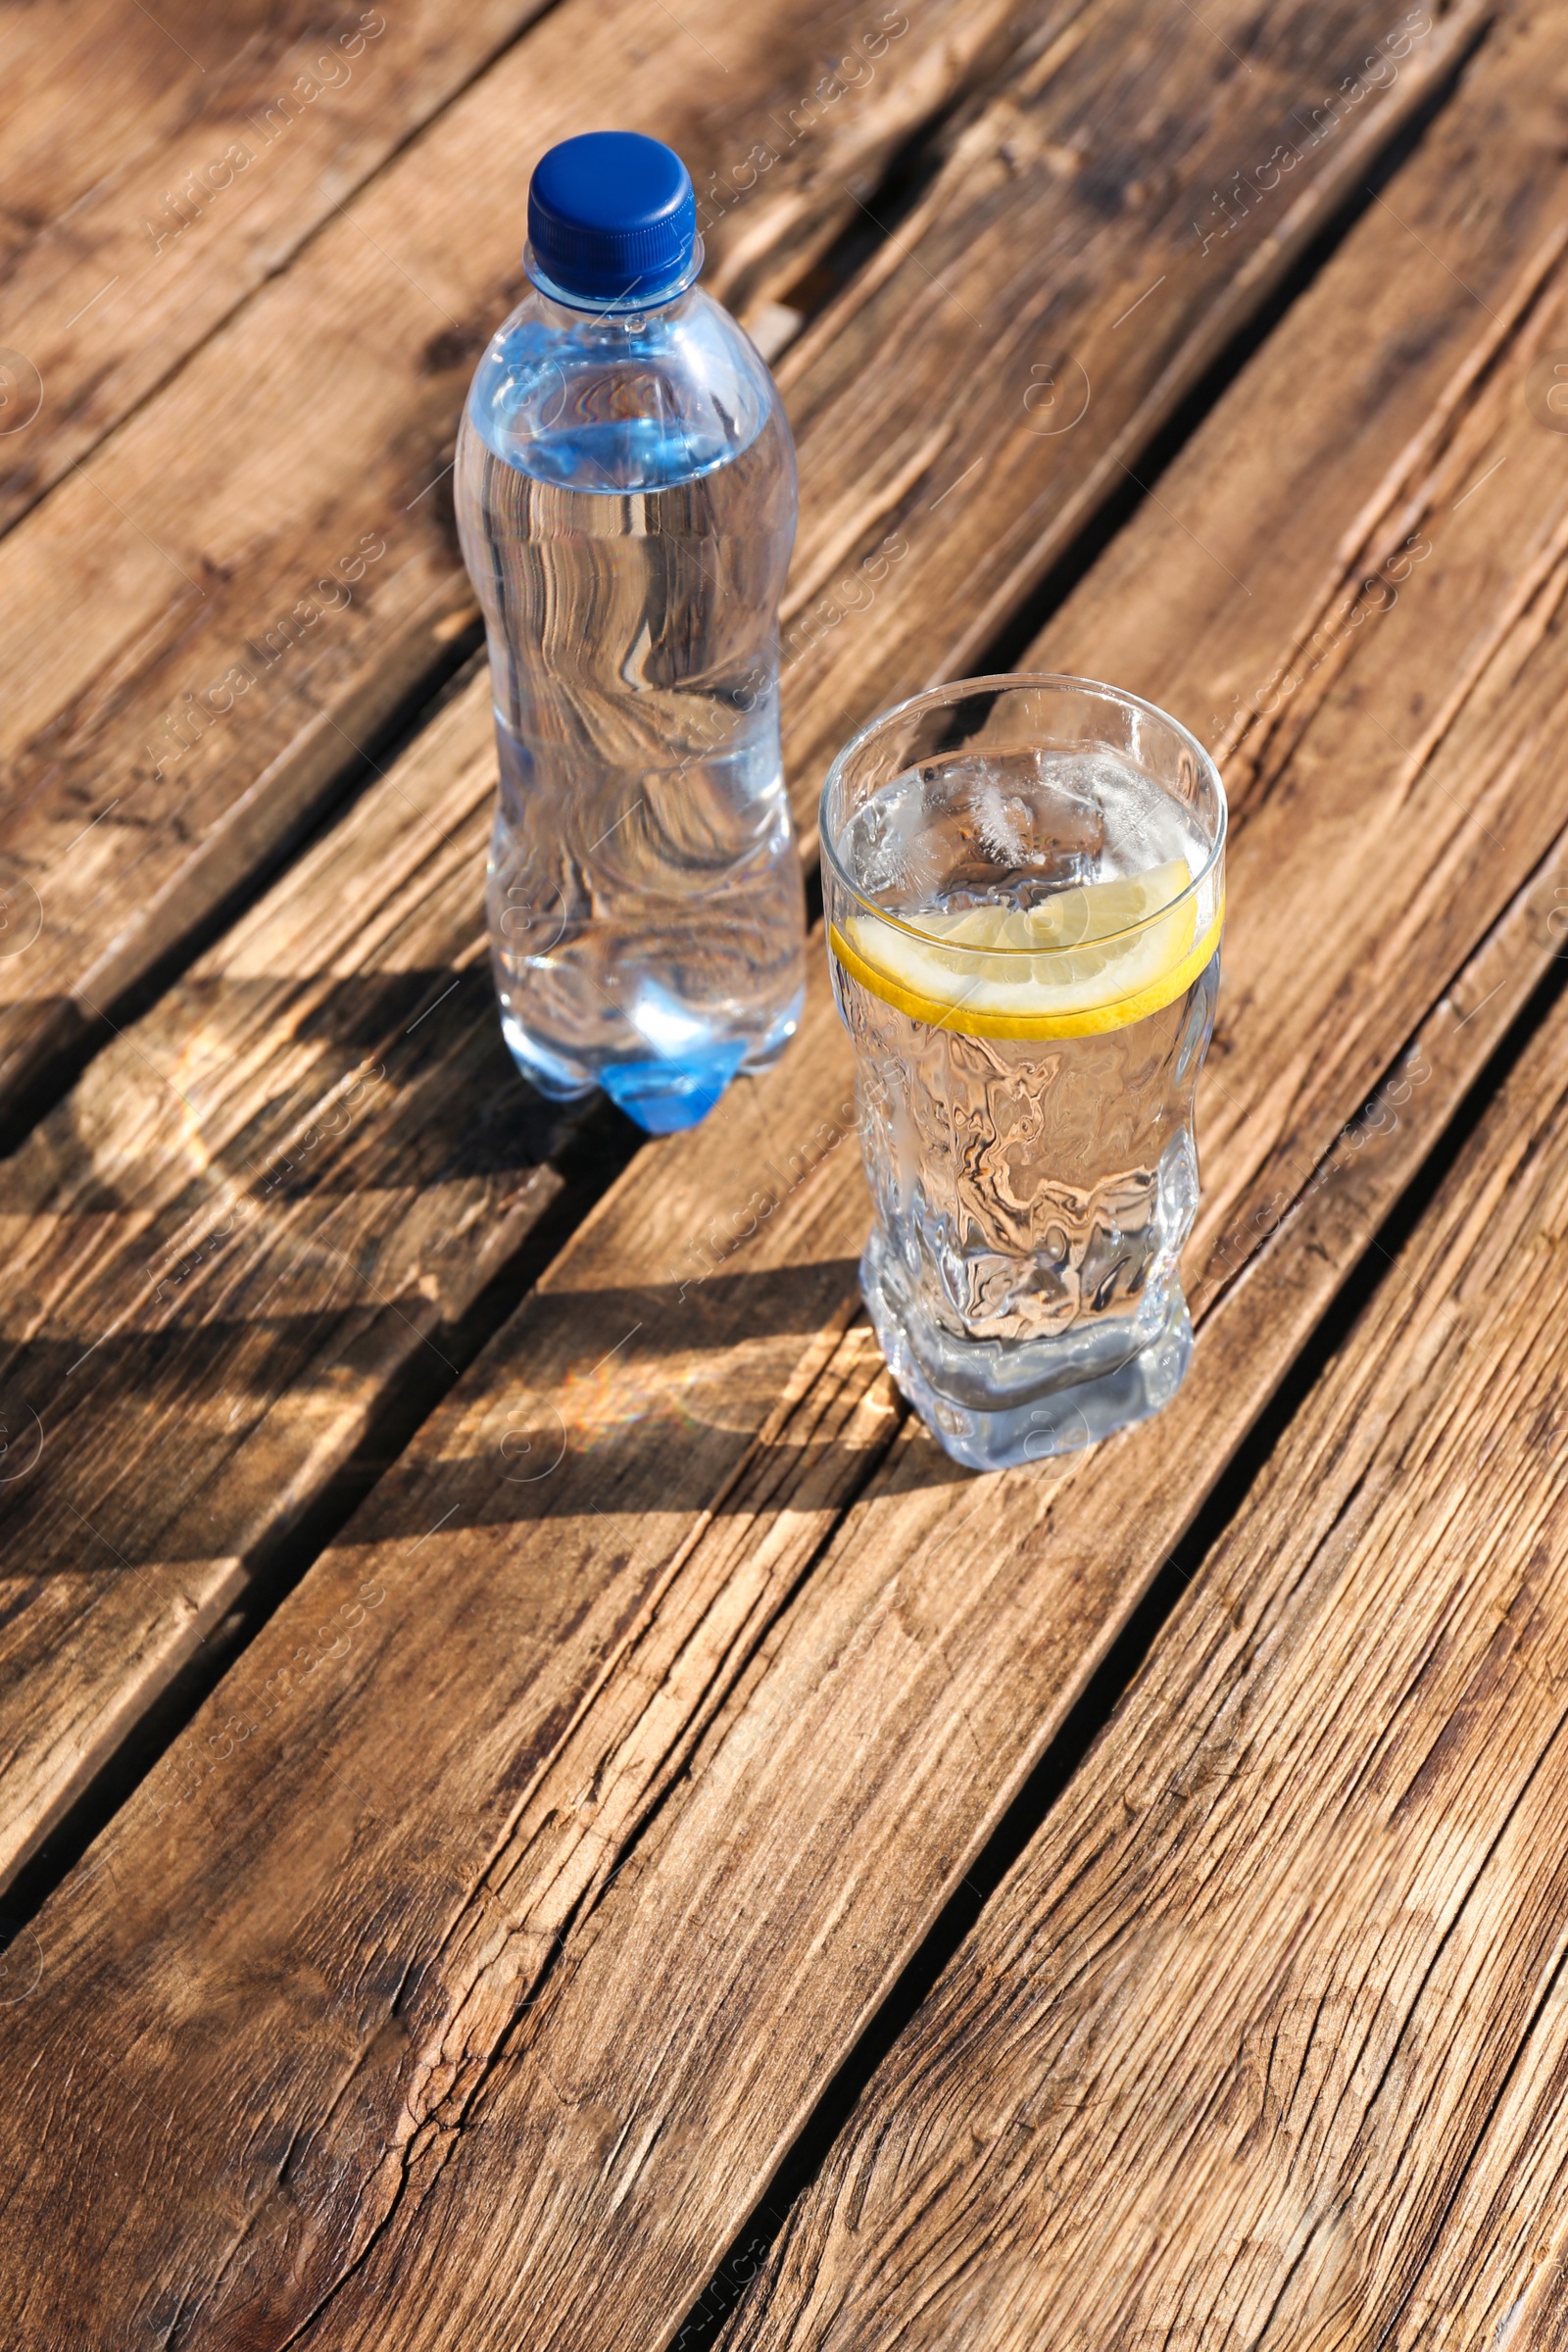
[456,131,804,1134]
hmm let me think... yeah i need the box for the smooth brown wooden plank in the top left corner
[0,0,557,529]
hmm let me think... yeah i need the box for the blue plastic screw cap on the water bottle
[524,131,703,311]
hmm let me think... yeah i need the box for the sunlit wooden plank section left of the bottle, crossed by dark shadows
[0,680,562,1880]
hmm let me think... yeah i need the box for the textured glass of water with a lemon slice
[820,675,1225,1470]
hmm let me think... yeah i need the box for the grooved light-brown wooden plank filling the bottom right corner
[724,907,1568,2352]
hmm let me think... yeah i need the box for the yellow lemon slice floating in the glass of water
[827,858,1225,1037]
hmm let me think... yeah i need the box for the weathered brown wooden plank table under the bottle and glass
[0,0,1568,2352]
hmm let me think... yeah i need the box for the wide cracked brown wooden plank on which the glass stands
[0,14,1568,2352]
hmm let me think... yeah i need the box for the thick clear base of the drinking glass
[860,1233,1192,1470]
